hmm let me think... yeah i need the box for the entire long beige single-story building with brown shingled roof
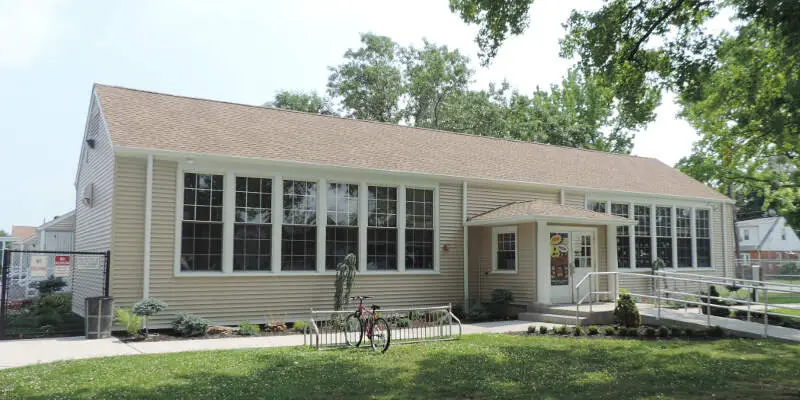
[73,85,734,326]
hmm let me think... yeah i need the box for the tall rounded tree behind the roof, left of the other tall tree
[328,33,403,123]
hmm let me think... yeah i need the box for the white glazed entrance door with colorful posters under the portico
[550,229,594,304]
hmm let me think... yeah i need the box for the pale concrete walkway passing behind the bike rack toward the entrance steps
[0,321,536,369]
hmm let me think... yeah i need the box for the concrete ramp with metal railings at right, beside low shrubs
[640,308,800,343]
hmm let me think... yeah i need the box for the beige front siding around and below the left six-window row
[111,158,464,326]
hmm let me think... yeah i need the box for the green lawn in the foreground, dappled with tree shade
[0,335,800,400]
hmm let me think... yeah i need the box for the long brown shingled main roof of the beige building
[94,85,730,201]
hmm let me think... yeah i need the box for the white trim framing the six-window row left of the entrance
[173,161,441,278]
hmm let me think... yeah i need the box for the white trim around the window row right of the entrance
[585,196,712,271]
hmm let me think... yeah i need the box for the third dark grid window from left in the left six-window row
[281,180,317,271]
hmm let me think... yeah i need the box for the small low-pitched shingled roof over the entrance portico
[467,200,636,226]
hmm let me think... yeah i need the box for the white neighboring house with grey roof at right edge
[736,217,800,274]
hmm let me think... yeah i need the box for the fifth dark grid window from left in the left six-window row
[367,186,397,270]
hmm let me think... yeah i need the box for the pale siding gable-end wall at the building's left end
[72,102,114,315]
